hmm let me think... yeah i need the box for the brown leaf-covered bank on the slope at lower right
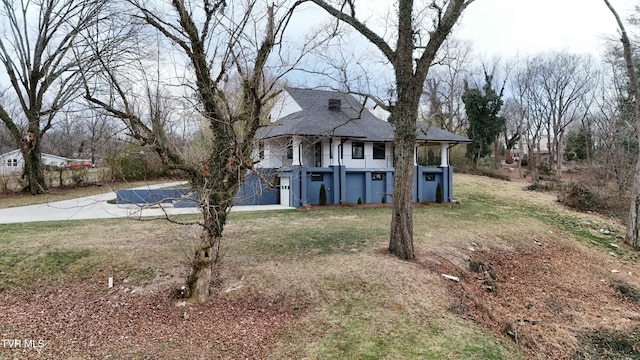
[418,243,640,359]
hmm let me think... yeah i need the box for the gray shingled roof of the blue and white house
[256,87,471,142]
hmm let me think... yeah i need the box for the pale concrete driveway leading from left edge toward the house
[0,182,293,224]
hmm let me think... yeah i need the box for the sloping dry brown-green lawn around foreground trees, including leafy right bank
[0,174,640,359]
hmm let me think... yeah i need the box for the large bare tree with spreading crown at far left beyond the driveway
[0,0,107,194]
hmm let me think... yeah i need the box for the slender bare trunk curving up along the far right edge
[604,0,640,249]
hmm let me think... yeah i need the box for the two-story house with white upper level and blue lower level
[236,88,471,207]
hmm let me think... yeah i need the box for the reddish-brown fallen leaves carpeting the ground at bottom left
[0,281,299,359]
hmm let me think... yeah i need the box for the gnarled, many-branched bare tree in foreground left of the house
[86,0,316,302]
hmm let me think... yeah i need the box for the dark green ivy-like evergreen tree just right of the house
[462,72,506,166]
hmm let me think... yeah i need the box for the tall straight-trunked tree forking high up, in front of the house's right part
[300,0,473,260]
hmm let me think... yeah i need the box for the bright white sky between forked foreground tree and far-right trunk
[456,0,638,58]
